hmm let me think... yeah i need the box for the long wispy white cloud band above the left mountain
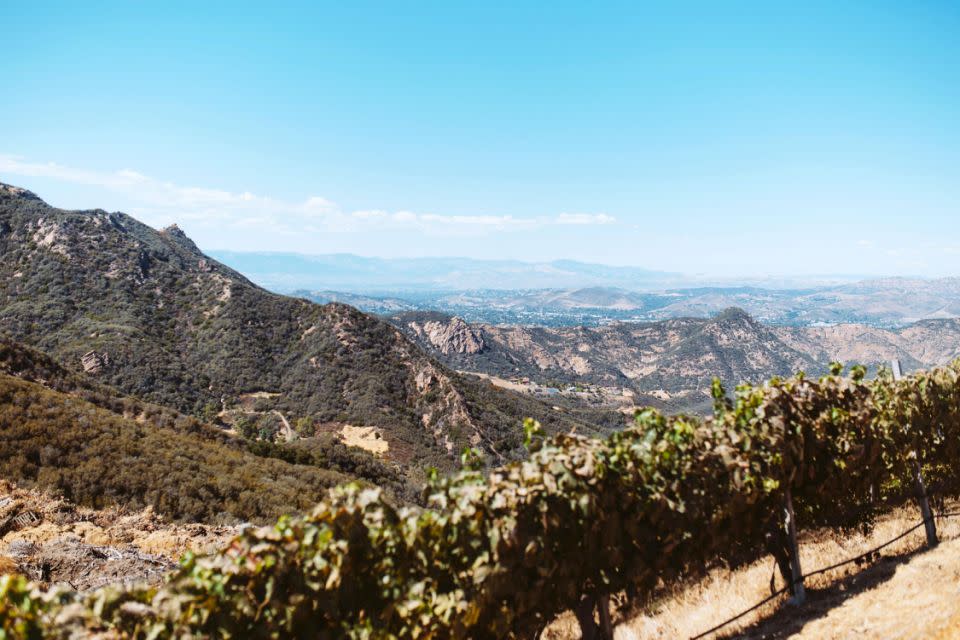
[0,154,616,235]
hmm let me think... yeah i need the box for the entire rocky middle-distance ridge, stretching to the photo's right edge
[392,308,960,409]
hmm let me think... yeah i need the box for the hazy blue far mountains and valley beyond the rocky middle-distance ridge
[204,251,960,327]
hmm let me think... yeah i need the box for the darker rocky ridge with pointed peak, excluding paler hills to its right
[394,309,817,393]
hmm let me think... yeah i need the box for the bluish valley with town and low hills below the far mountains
[282,276,960,328]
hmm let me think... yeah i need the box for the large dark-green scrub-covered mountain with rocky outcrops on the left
[0,181,612,474]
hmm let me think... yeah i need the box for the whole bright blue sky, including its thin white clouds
[0,0,960,276]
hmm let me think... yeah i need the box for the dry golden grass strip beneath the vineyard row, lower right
[543,505,960,640]
